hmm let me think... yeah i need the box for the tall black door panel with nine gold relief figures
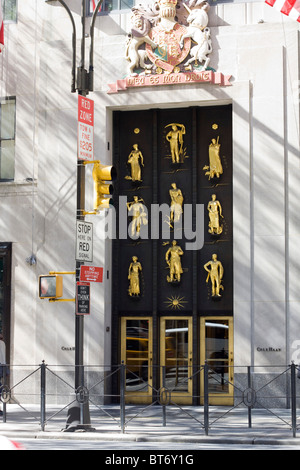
[112,105,233,404]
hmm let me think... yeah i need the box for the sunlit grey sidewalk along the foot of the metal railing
[0,405,300,446]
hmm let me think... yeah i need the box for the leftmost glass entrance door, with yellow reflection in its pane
[121,317,152,403]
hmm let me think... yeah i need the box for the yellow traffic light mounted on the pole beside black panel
[93,161,117,211]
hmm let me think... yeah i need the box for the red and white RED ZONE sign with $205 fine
[78,95,94,161]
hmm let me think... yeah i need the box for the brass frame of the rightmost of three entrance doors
[200,316,234,406]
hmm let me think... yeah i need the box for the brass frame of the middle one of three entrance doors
[160,316,193,405]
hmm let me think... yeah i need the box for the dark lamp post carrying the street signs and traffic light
[45,0,103,431]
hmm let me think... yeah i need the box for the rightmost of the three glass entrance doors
[200,317,233,405]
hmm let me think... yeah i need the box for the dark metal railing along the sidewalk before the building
[0,361,300,437]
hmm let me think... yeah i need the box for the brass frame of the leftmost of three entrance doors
[121,316,153,404]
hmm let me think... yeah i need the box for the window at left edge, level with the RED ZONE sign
[0,98,16,181]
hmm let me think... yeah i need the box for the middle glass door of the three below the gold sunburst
[161,317,193,404]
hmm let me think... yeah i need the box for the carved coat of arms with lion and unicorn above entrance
[126,0,212,76]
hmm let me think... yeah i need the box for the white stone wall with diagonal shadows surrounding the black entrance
[0,0,300,400]
